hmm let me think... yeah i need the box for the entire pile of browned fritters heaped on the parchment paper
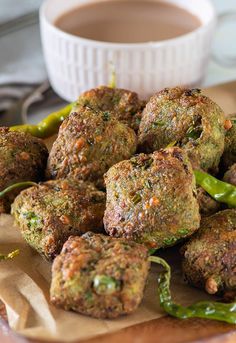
[0,87,236,318]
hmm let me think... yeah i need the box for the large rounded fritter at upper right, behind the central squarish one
[139,87,225,171]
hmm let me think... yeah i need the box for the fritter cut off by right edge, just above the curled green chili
[182,209,236,295]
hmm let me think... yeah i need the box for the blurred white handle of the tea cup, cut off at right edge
[212,11,236,67]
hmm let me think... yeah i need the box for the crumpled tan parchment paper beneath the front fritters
[0,215,216,342]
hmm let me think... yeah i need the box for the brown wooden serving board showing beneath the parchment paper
[0,81,236,343]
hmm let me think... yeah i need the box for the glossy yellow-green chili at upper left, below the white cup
[10,104,73,138]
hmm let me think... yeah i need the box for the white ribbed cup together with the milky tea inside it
[40,0,216,101]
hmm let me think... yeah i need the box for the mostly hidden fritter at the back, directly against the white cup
[72,86,145,131]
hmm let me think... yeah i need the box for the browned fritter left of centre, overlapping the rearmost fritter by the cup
[48,108,137,187]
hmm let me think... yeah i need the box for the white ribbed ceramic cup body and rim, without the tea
[40,0,216,101]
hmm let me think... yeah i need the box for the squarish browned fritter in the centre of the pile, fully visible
[104,148,200,248]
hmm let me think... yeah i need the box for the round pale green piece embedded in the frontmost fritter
[93,275,119,294]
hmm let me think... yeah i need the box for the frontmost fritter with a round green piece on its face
[50,233,150,318]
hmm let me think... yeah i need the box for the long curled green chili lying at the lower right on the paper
[149,256,236,324]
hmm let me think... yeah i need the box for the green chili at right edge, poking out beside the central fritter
[194,170,236,207]
